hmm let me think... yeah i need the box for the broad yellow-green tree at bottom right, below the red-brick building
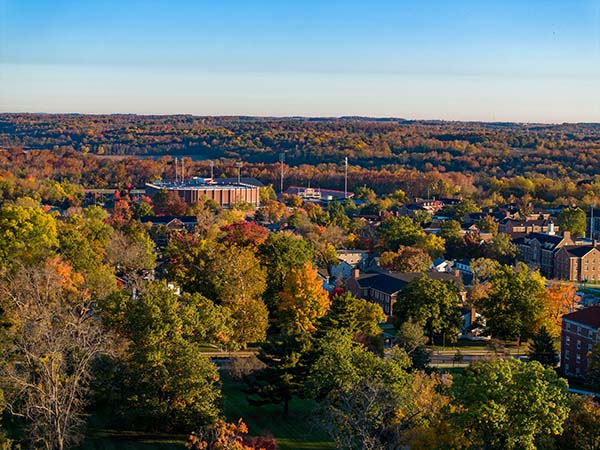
[451,359,569,450]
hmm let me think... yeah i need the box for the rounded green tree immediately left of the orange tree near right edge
[476,264,546,339]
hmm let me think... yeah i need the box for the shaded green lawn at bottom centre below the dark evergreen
[222,375,335,450]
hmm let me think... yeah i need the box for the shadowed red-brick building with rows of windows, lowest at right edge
[560,305,600,377]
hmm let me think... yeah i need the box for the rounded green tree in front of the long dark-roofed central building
[394,275,462,342]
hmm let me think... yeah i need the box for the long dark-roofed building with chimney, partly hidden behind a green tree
[346,269,462,318]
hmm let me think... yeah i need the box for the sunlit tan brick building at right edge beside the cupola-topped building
[554,241,600,281]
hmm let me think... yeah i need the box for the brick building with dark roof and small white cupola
[513,229,575,278]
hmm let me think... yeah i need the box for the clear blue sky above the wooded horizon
[0,0,600,122]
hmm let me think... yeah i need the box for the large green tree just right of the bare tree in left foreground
[100,282,221,430]
